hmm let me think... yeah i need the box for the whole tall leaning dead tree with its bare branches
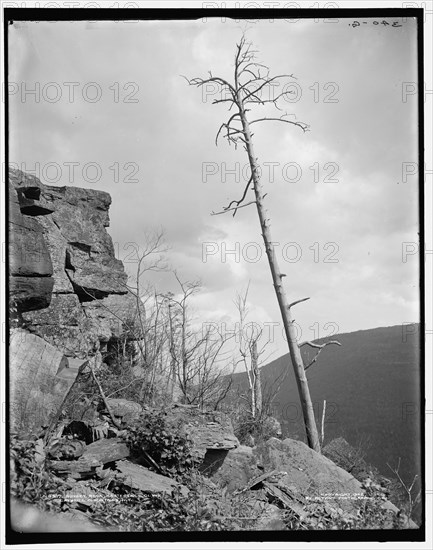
[184,36,340,452]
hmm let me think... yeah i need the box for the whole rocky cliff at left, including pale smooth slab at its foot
[9,170,136,438]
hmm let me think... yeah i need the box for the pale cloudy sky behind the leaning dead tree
[9,14,419,362]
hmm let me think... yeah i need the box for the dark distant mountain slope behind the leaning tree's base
[231,324,424,486]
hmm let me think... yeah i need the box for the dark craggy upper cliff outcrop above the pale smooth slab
[9,169,135,357]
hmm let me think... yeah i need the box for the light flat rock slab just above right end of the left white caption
[116,460,188,496]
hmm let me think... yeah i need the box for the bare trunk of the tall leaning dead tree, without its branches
[237,103,320,453]
